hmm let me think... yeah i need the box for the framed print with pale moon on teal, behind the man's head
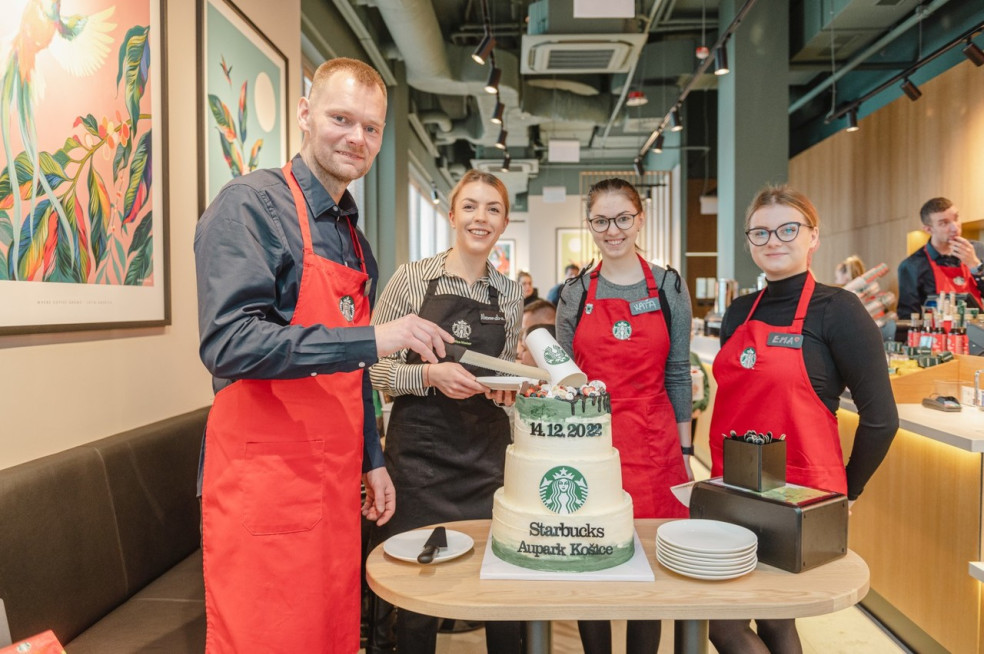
[198,0,289,215]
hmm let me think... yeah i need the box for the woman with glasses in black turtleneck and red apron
[710,186,899,654]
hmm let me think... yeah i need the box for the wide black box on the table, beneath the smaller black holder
[690,477,847,572]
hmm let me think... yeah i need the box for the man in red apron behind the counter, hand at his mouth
[898,198,984,320]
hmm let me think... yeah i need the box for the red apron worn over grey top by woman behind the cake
[574,257,687,518]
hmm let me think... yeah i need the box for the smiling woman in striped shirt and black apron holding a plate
[370,170,522,654]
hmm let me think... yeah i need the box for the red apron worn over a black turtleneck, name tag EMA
[710,273,847,495]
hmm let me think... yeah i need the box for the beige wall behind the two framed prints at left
[0,0,301,468]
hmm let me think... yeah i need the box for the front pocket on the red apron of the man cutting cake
[241,440,324,536]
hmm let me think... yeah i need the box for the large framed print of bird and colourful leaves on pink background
[0,0,171,335]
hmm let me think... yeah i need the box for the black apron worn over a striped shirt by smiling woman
[376,279,510,542]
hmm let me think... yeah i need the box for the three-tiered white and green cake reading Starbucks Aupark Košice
[492,393,634,572]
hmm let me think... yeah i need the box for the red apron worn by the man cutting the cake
[202,163,369,654]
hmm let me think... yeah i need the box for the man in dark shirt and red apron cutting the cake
[195,59,452,654]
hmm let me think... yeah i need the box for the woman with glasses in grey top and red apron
[557,179,693,654]
